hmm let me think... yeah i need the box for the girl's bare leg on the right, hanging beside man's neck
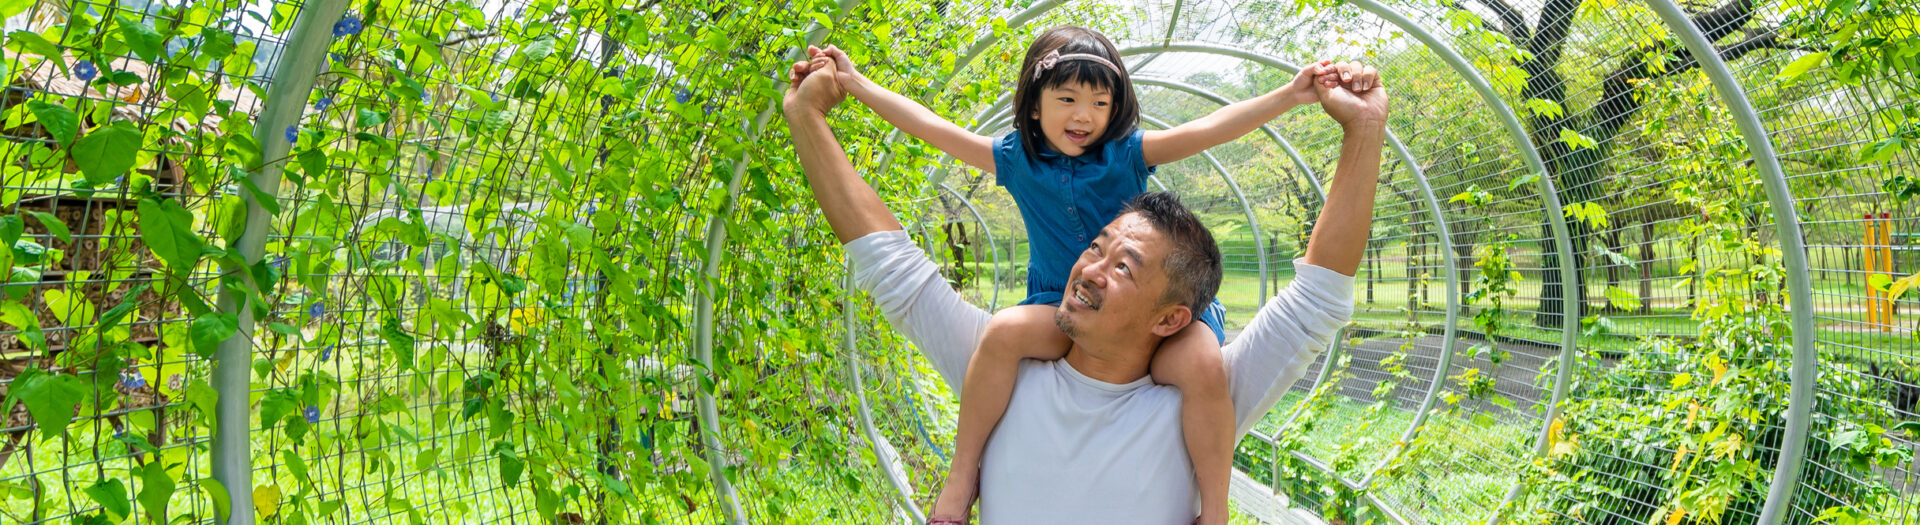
[1150,321,1235,525]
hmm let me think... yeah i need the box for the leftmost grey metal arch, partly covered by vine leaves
[209,0,348,525]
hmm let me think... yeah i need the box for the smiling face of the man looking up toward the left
[1054,213,1185,338]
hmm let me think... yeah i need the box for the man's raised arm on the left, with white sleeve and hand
[783,58,991,392]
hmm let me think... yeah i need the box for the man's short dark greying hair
[1119,192,1223,319]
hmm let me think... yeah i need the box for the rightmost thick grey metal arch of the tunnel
[1647,0,1820,525]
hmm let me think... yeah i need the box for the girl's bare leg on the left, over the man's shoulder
[927,304,1082,521]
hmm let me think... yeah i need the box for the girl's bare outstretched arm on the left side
[808,46,993,173]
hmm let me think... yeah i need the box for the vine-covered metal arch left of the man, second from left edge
[691,0,860,525]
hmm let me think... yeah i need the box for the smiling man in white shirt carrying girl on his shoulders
[783,52,1388,525]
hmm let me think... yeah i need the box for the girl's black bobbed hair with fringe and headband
[1014,25,1140,158]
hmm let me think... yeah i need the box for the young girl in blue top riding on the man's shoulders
[810,27,1329,525]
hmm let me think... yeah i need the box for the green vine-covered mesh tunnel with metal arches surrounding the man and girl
[0,0,1920,525]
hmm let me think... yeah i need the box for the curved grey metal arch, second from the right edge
[1348,0,1580,523]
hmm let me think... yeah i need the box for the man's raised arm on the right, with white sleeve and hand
[1225,63,1386,435]
